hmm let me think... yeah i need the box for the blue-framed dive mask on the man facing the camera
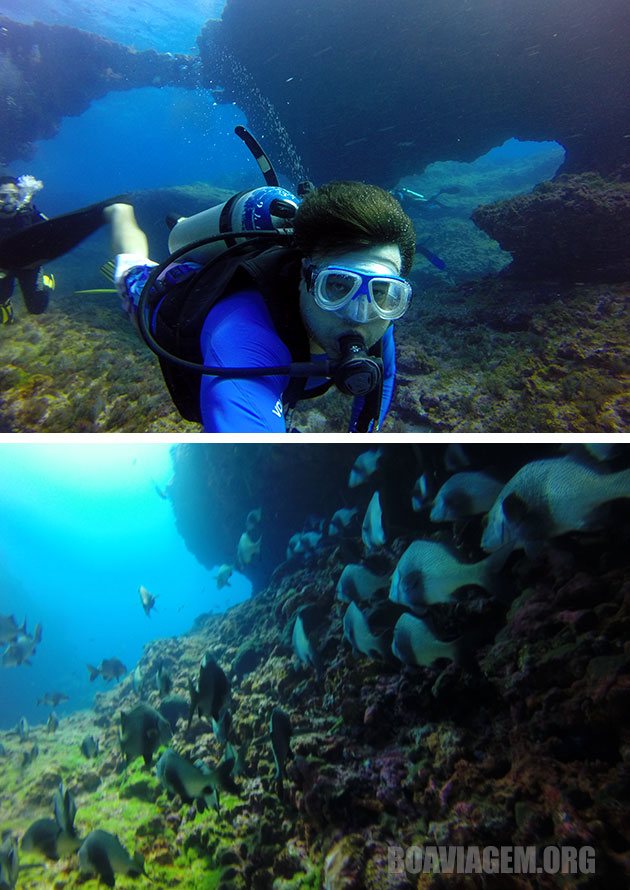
[303,263,412,324]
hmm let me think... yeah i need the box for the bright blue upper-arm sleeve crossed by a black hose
[200,290,291,433]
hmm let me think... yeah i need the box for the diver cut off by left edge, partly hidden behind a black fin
[0,176,55,324]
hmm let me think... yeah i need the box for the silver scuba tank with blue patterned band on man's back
[168,185,300,263]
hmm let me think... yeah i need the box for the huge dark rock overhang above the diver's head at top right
[206,0,630,186]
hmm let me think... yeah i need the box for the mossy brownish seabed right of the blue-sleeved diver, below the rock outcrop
[390,278,630,433]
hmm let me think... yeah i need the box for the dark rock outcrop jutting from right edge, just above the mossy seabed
[472,174,630,282]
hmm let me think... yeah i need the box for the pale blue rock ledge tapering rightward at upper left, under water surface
[0,16,199,164]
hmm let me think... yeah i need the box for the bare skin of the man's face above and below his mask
[300,244,402,359]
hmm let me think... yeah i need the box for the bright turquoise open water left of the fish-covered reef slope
[0,443,251,728]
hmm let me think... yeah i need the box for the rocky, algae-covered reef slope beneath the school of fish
[0,482,630,890]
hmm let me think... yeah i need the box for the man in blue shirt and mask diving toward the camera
[104,127,415,433]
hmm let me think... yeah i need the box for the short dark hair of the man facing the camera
[294,181,416,275]
